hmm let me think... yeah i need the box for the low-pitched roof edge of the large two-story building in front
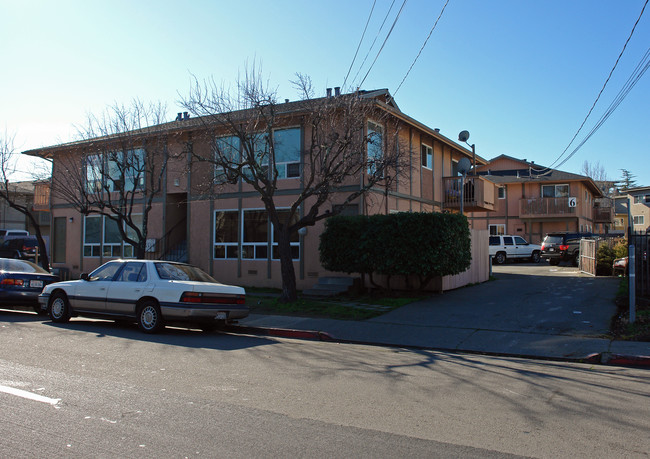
[22,89,487,164]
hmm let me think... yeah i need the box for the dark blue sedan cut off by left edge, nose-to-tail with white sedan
[0,258,59,314]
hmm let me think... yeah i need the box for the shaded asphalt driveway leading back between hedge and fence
[372,262,618,337]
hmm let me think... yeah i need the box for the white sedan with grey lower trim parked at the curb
[39,260,249,333]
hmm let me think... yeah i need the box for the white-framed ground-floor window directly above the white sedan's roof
[84,215,142,258]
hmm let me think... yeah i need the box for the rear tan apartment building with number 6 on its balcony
[469,155,613,243]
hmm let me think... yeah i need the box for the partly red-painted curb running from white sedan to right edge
[225,325,650,368]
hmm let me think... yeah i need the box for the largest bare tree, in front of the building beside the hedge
[182,66,406,302]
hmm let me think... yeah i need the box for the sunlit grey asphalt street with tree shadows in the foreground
[0,311,650,458]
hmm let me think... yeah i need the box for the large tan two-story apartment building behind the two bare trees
[25,90,494,289]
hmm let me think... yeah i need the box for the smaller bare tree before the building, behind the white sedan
[52,99,168,258]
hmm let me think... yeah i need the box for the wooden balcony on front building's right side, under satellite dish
[442,175,495,212]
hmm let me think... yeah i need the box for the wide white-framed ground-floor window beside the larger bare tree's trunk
[214,210,300,260]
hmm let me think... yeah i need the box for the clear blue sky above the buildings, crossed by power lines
[0,0,650,185]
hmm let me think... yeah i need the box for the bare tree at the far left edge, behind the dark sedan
[0,132,50,271]
